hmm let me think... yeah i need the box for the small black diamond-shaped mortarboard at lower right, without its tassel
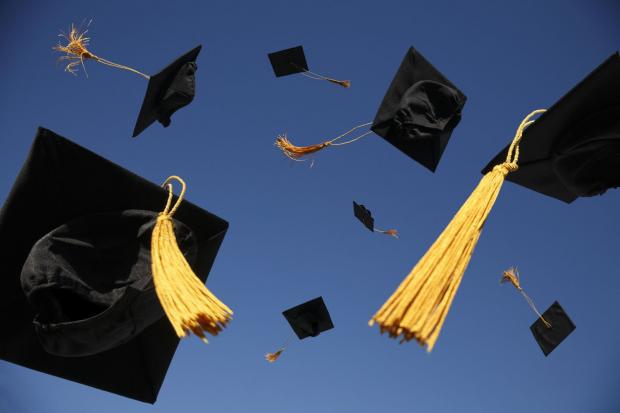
[530,301,575,357]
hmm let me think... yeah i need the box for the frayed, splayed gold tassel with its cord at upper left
[53,22,150,79]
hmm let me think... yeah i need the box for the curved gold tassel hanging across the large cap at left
[151,176,233,343]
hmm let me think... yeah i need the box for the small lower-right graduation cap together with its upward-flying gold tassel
[500,267,575,357]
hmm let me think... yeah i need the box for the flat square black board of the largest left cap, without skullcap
[0,128,228,403]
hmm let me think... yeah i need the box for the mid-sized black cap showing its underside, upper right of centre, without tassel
[371,47,467,172]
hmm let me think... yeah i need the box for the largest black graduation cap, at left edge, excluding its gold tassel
[0,128,228,403]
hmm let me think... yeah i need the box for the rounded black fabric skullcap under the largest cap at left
[21,210,197,357]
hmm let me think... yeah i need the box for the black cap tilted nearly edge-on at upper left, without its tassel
[133,45,202,138]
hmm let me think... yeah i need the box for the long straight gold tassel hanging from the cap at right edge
[368,109,544,352]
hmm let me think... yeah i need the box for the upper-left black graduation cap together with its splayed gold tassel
[54,25,202,137]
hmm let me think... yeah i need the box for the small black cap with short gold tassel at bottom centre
[265,297,334,363]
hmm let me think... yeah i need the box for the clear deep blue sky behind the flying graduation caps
[0,0,620,413]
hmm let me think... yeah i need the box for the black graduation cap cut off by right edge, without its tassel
[482,52,620,203]
